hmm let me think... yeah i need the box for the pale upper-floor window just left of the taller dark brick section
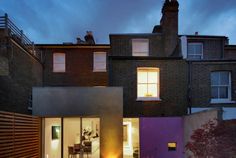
[93,52,107,72]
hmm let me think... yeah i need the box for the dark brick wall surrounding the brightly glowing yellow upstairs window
[109,58,188,117]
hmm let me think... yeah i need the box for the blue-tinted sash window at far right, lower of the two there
[211,71,231,103]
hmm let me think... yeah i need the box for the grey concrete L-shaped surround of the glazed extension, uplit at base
[33,87,123,158]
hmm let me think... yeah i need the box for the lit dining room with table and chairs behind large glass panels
[44,117,100,158]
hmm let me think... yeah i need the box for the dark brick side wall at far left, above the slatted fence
[0,38,42,114]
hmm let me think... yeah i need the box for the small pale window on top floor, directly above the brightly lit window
[132,38,149,56]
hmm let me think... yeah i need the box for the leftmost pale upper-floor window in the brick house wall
[53,52,66,73]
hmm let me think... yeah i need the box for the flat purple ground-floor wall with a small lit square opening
[140,117,184,158]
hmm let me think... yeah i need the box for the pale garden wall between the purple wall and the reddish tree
[183,109,221,158]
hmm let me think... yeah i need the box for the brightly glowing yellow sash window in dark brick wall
[137,68,160,100]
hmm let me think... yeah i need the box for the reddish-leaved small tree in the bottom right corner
[185,120,236,158]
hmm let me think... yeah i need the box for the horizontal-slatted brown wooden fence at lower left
[0,111,41,158]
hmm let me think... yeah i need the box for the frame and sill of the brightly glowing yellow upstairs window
[136,67,161,101]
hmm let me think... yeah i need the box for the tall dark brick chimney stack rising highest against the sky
[160,0,179,57]
